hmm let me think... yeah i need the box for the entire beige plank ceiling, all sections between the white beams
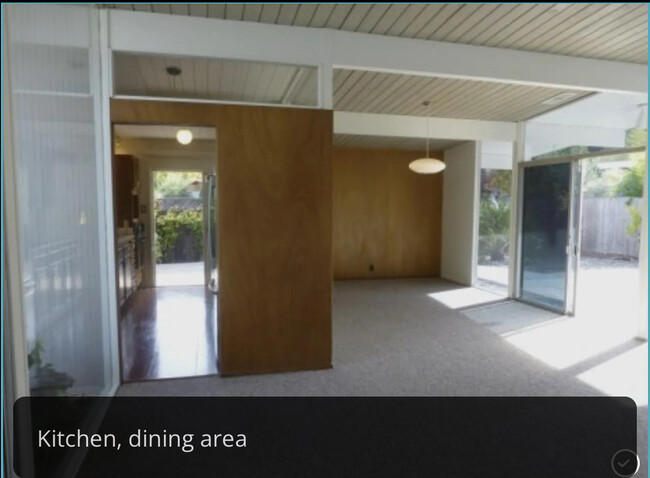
[103,3,648,146]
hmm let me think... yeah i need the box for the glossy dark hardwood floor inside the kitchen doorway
[120,286,217,382]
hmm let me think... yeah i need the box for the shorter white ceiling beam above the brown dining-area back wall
[334,111,517,141]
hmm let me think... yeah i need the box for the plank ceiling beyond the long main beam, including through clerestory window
[114,53,589,121]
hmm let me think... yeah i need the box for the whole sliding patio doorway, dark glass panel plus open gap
[518,144,646,320]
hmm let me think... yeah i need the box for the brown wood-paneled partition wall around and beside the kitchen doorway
[111,100,332,375]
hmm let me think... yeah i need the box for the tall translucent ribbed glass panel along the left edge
[8,5,110,395]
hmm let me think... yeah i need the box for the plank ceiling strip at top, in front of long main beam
[104,3,648,64]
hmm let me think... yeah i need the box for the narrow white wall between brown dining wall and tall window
[441,141,479,285]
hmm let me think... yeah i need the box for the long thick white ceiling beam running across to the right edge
[109,10,648,93]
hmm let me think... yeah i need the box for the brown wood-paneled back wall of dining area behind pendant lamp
[333,148,443,279]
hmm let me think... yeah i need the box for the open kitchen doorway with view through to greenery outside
[113,124,217,382]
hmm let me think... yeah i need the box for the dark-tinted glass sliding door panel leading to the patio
[518,160,582,315]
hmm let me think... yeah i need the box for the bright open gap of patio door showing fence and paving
[576,148,646,329]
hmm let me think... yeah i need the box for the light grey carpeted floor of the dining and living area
[118,279,647,476]
